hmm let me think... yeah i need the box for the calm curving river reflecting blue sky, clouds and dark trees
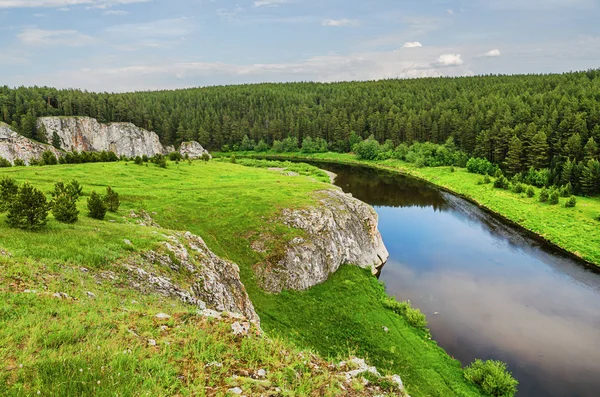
[319,164,600,397]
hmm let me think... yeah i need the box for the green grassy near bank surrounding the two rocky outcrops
[0,162,480,396]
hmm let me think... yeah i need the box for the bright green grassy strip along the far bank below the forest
[221,152,600,269]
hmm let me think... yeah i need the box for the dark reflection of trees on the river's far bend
[318,164,448,211]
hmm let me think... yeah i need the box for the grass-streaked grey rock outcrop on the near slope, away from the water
[124,232,259,323]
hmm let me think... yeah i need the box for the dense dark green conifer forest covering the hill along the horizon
[0,70,600,168]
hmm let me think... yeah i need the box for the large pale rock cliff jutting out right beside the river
[256,189,389,292]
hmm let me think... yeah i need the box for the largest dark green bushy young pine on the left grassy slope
[6,182,50,230]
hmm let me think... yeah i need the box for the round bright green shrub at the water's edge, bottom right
[464,360,519,397]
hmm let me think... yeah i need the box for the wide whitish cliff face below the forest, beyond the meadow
[38,117,165,157]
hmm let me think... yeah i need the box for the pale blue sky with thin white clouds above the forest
[0,0,600,92]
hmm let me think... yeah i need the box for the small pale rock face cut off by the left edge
[0,123,61,164]
